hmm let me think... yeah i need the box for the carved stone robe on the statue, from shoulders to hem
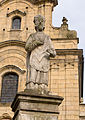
[25,32,56,84]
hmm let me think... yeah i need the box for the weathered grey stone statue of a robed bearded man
[25,15,56,93]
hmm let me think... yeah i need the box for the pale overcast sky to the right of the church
[53,0,85,101]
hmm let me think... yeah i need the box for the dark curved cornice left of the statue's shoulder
[0,40,26,48]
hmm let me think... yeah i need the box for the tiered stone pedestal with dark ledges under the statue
[11,90,63,120]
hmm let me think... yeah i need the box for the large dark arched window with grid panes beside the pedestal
[1,72,18,103]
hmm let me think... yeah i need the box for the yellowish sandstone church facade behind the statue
[0,0,85,120]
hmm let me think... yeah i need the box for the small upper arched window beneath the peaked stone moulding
[12,16,21,29]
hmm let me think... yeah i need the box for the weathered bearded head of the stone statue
[34,15,45,31]
